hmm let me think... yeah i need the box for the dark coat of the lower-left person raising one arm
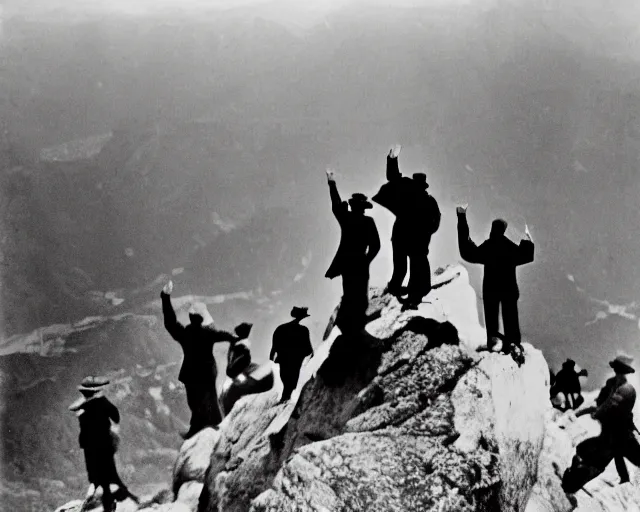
[160,292,237,385]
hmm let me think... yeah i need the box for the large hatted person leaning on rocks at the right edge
[562,354,640,493]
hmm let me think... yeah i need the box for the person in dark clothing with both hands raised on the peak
[457,206,534,353]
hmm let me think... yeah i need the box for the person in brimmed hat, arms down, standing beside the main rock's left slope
[269,306,313,402]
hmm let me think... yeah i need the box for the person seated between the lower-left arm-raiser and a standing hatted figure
[220,323,274,415]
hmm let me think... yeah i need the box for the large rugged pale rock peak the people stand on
[58,266,637,512]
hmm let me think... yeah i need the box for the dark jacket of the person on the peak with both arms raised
[458,214,534,299]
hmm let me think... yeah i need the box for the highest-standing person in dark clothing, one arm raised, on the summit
[373,146,440,309]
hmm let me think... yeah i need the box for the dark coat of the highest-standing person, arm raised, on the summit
[372,156,441,251]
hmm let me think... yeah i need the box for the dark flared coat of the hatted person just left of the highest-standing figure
[325,181,380,279]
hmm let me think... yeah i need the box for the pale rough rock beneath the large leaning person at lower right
[525,396,640,512]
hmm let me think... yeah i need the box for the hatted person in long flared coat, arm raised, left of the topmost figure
[325,170,380,333]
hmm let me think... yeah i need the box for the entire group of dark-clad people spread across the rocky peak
[66,145,640,512]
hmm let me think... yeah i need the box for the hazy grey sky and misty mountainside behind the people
[0,0,640,510]
